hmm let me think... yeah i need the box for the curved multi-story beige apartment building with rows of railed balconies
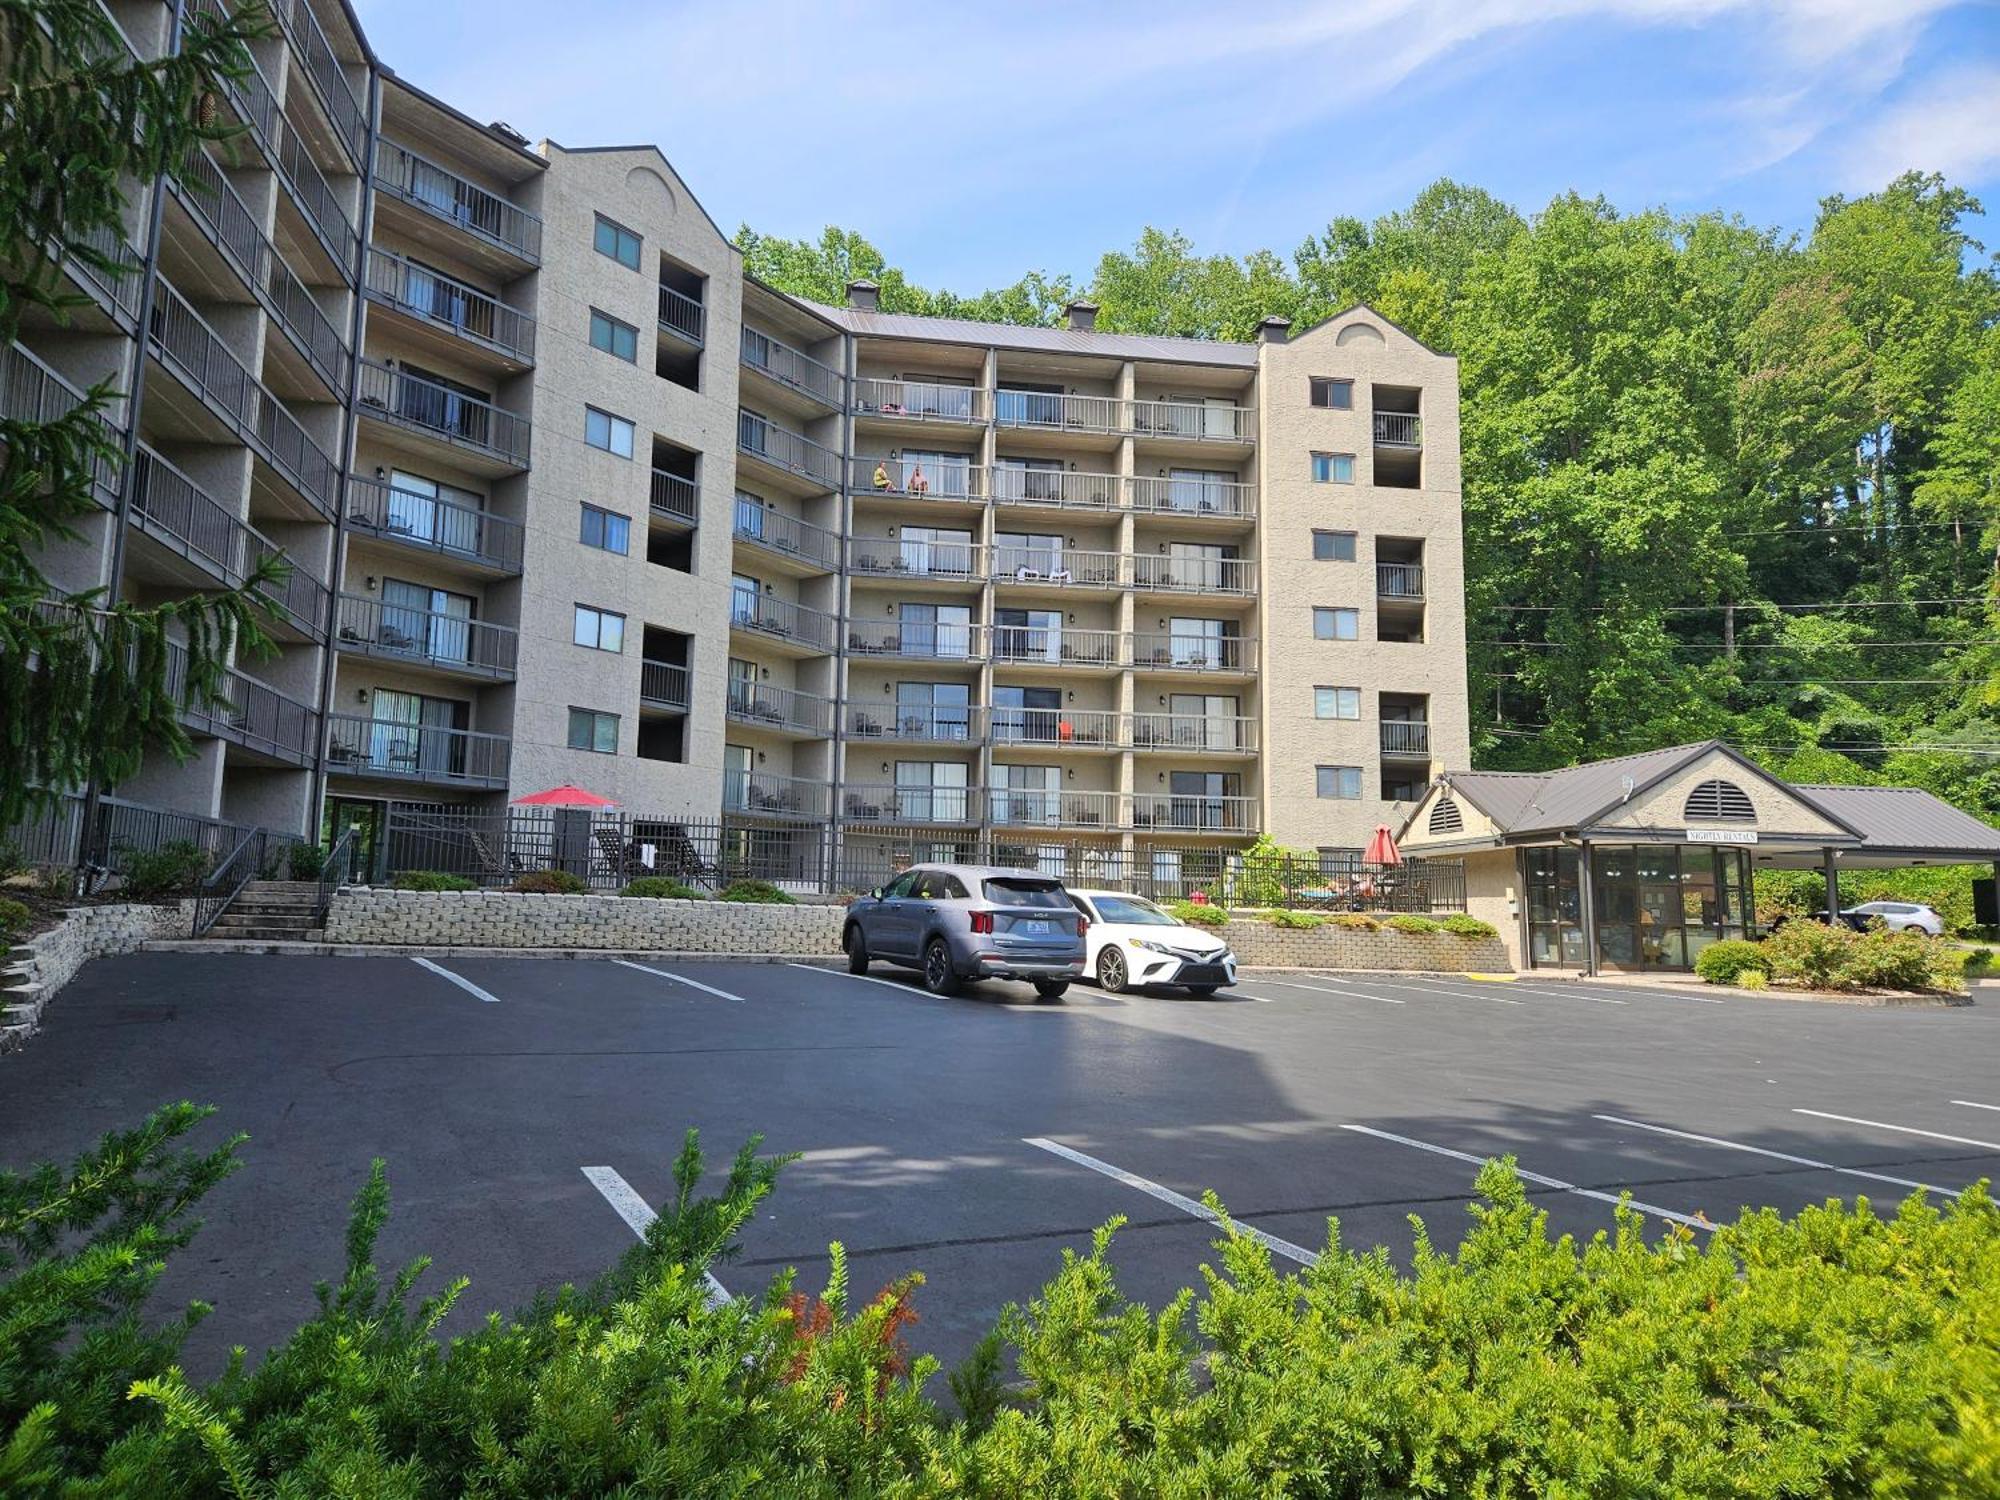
[4,0,1468,880]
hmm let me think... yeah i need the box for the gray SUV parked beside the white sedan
[840,864,1090,1000]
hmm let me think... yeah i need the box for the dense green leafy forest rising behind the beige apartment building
[738,174,2000,840]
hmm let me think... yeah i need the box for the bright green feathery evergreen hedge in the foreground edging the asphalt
[0,1104,2000,1500]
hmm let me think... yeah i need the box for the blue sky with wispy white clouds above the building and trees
[356,0,2000,292]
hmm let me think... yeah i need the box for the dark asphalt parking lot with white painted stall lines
[0,954,2000,1372]
